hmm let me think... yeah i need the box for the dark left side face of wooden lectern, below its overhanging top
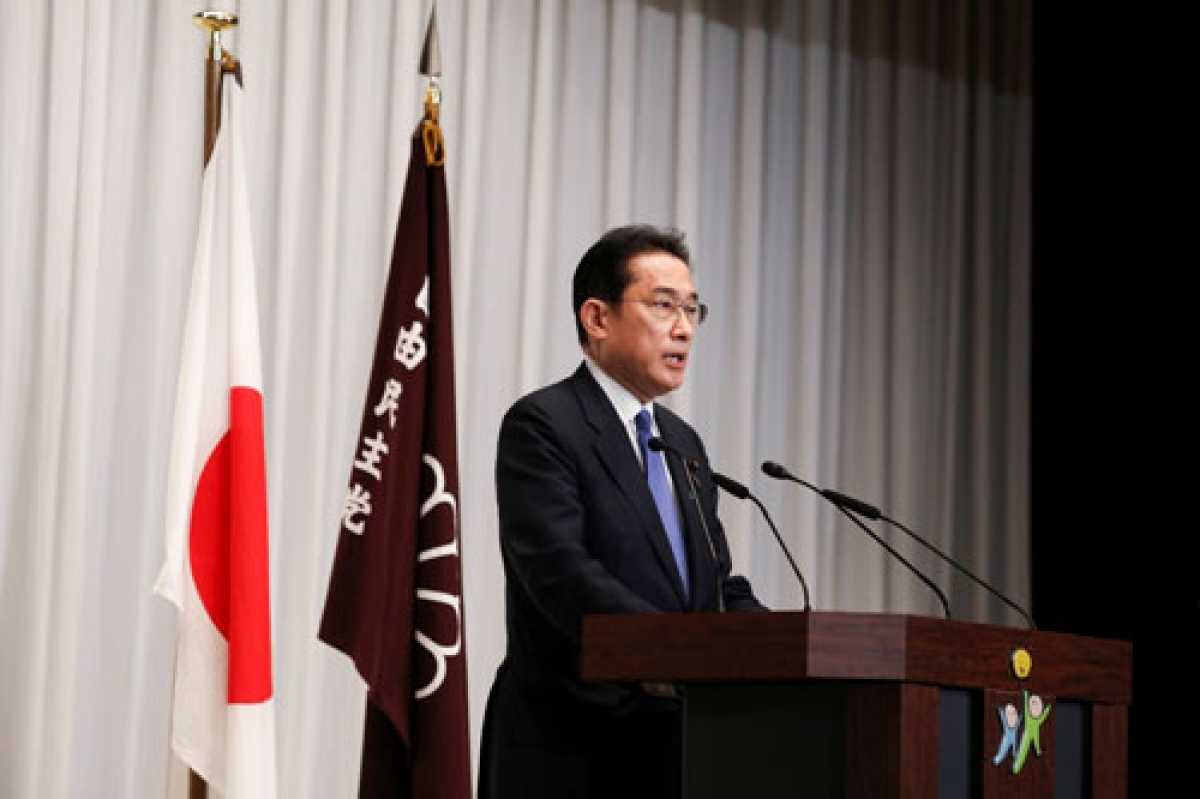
[684,680,945,799]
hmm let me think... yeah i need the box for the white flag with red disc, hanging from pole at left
[155,80,276,799]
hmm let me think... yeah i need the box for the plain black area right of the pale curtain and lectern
[1031,7,1200,782]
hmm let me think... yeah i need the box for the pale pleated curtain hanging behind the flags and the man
[0,0,1032,799]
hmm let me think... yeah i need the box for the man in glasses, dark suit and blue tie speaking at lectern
[479,226,766,799]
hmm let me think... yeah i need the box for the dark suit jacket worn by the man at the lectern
[480,365,764,799]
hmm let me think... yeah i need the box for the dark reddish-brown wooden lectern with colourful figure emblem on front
[582,611,1133,799]
